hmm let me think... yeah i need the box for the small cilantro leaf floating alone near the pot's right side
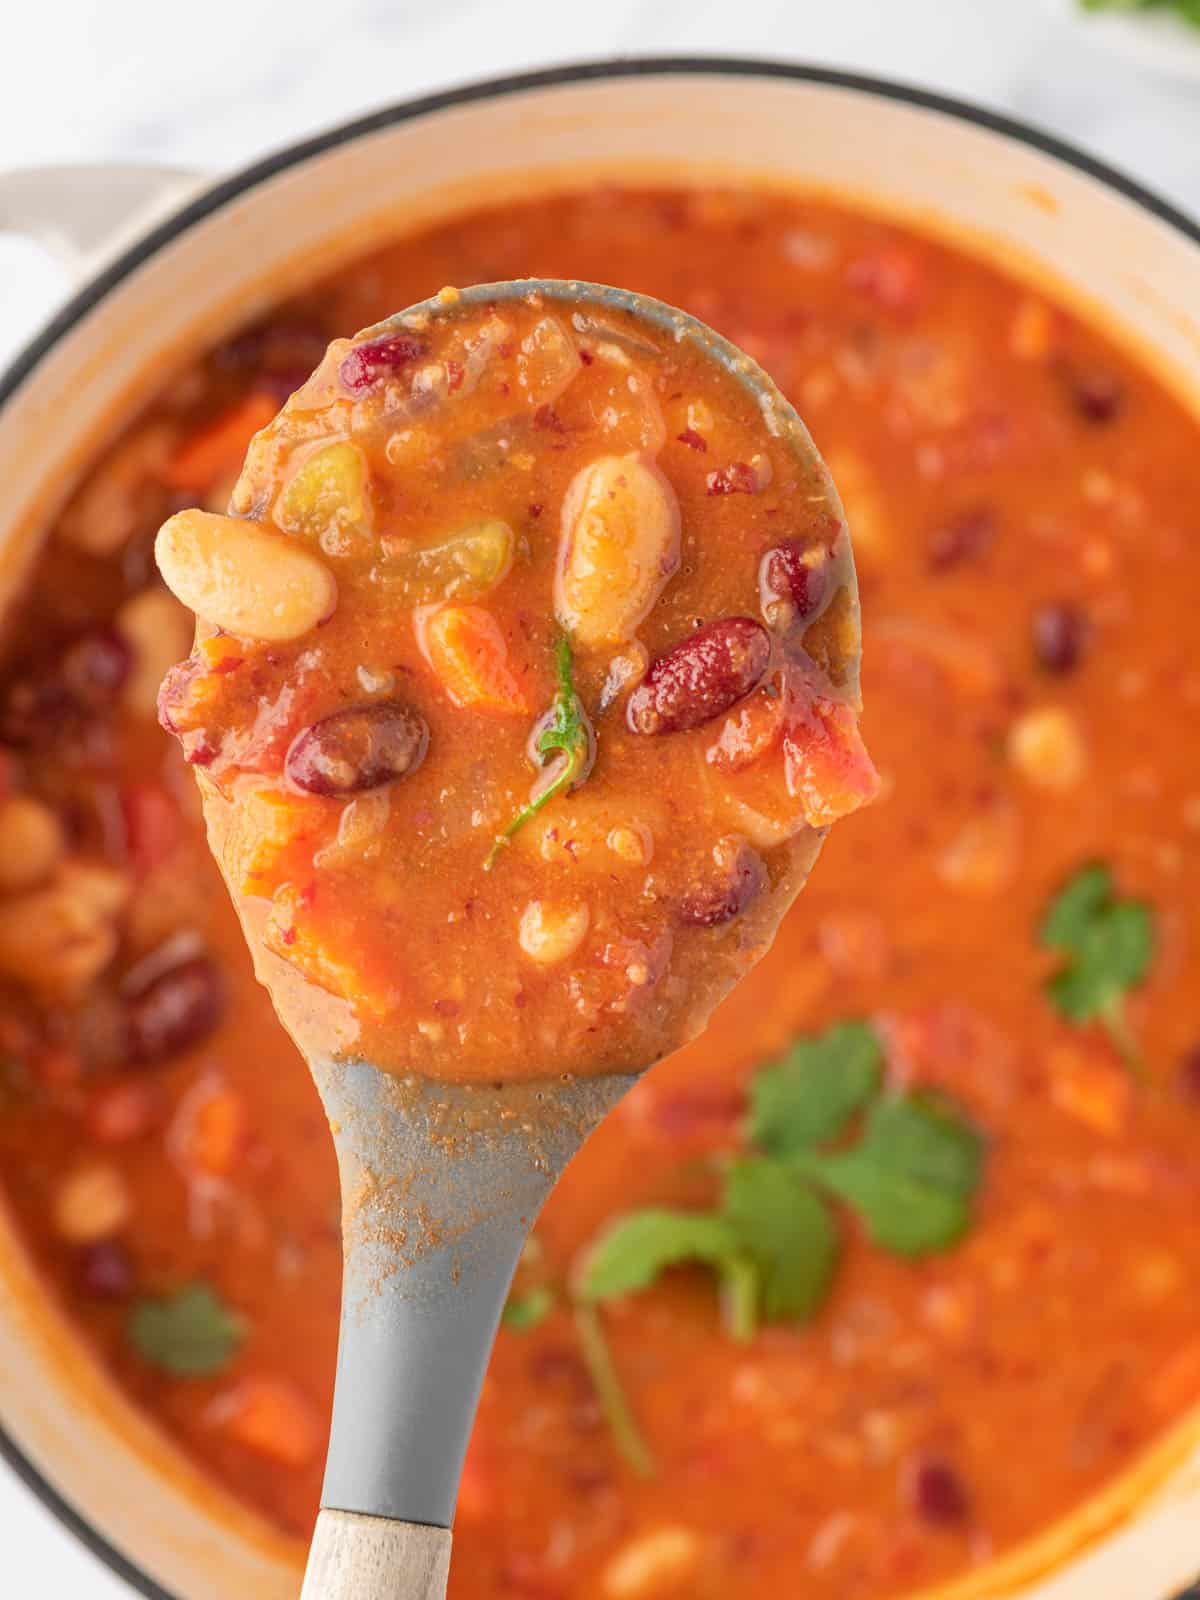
[1040,862,1155,1064]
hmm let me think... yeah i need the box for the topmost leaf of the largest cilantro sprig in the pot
[747,1022,883,1157]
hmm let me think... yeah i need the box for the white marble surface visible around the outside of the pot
[0,0,1200,1600]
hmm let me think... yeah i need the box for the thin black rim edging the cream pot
[0,56,1200,1600]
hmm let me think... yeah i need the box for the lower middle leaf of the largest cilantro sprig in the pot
[722,1155,838,1336]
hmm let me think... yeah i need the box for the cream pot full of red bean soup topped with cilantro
[0,61,1200,1600]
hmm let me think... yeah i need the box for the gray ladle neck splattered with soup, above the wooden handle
[312,1061,630,1529]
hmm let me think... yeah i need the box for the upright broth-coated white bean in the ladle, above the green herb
[554,456,680,646]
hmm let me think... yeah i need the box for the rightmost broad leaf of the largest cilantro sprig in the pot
[795,1093,984,1256]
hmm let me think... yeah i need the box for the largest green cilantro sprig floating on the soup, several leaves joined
[576,1022,984,1459]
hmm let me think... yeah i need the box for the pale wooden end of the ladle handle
[301,1510,450,1600]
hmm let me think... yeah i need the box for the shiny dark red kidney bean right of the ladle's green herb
[626,616,771,733]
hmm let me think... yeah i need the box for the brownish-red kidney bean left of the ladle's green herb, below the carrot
[283,701,429,795]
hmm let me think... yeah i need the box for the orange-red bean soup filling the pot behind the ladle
[0,190,1200,1600]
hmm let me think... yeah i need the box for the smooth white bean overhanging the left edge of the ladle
[154,510,338,643]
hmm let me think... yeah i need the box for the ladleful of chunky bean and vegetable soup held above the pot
[158,290,877,1080]
